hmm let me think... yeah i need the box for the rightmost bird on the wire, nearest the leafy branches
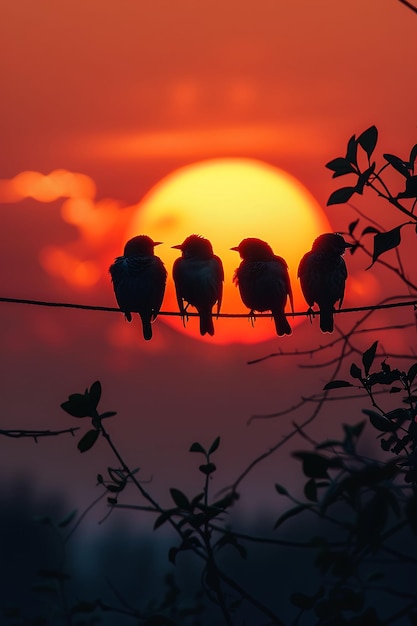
[298,233,353,333]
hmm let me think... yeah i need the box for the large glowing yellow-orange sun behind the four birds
[126,158,331,344]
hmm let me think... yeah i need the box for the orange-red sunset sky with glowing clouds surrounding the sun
[0,0,417,506]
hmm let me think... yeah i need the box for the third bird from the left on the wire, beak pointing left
[231,237,294,336]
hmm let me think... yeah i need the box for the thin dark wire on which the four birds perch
[0,296,417,318]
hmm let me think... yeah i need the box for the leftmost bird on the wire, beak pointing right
[109,235,167,341]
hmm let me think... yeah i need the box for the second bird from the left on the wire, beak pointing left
[172,235,224,336]
